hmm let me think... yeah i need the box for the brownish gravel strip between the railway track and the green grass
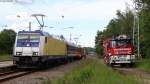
[1,59,86,84]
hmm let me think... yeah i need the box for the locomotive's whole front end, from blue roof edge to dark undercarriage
[13,31,44,65]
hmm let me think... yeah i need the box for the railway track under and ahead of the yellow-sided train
[0,58,84,84]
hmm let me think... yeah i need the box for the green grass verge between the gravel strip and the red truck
[44,60,141,84]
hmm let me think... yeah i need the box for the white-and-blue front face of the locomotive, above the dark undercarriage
[14,34,40,56]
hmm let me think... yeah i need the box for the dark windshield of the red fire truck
[112,39,131,47]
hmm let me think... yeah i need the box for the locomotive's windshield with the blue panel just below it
[16,34,40,47]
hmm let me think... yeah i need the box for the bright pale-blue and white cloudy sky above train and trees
[0,0,132,46]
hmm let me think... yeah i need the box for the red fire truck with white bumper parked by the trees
[102,34,136,66]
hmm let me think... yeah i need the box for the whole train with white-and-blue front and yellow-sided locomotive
[13,30,86,68]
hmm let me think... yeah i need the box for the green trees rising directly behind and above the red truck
[95,7,134,57]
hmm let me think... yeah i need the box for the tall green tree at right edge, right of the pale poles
[134,0,150,58]
